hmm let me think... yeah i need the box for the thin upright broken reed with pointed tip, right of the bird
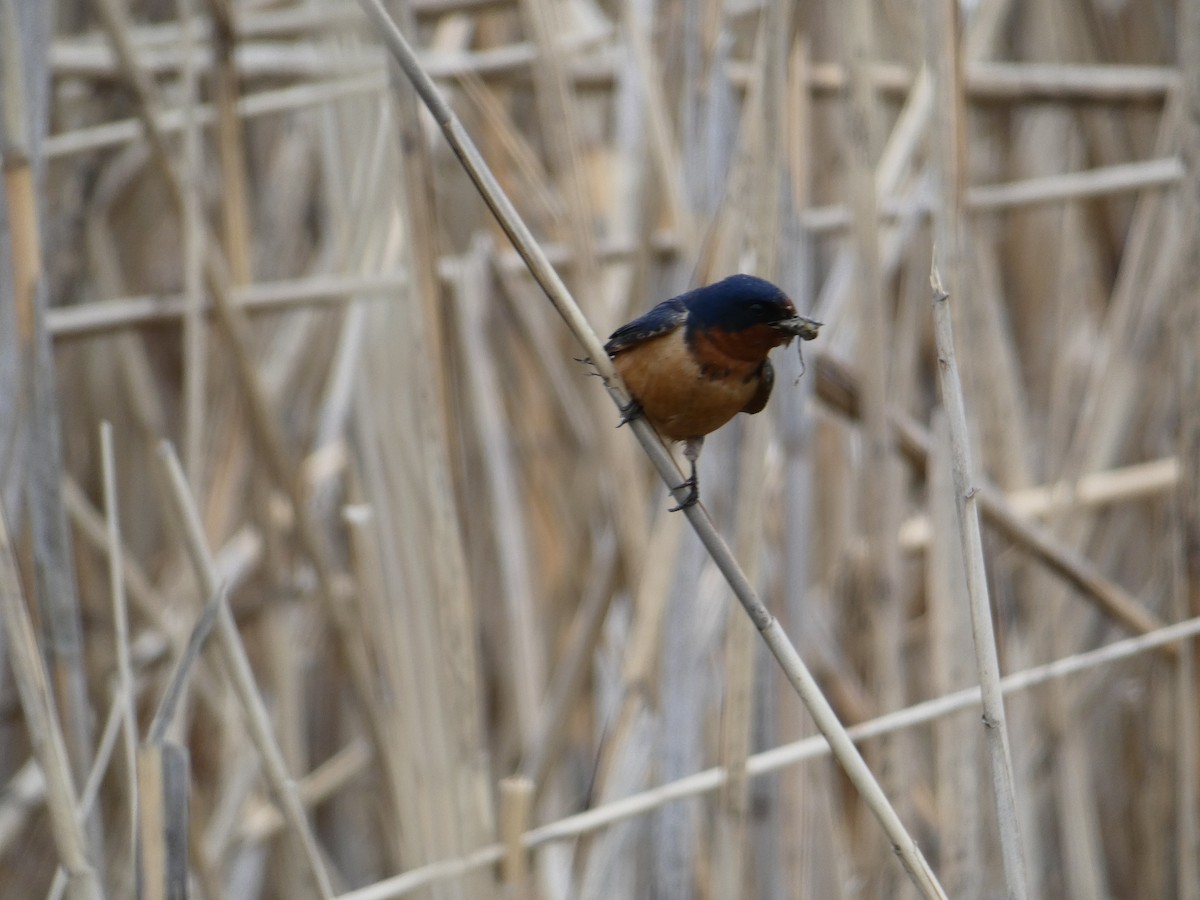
[930,260,1027,898]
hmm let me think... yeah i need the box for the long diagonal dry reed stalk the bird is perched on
[360,0,946,898]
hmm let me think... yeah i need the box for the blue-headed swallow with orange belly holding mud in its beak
[605,274,821,512]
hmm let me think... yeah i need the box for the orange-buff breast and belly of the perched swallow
[613,329,778,440]
